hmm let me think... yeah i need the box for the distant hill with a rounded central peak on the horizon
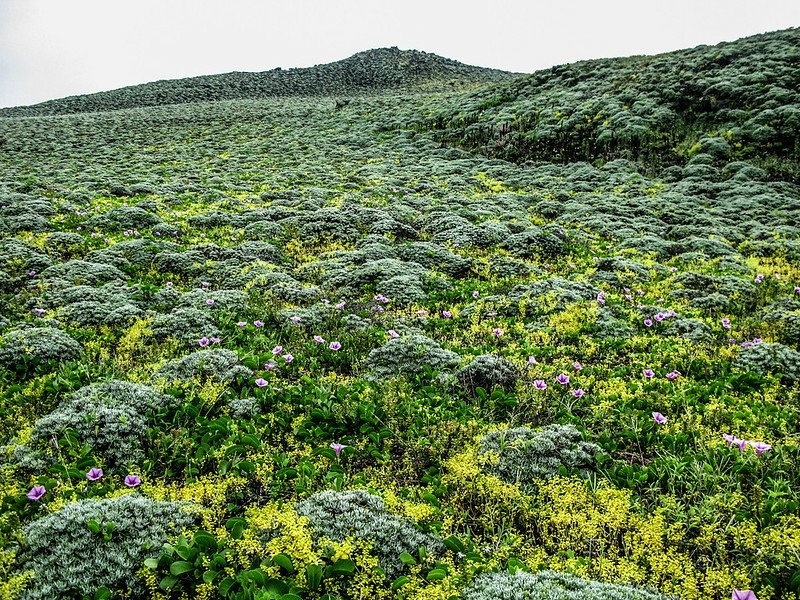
[0,47,514,116]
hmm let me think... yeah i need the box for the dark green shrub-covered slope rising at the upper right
[400,28,800,181]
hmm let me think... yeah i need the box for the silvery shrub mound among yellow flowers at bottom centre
[295,490,444,578]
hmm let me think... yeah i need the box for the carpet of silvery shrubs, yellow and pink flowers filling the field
[0,30,800,600]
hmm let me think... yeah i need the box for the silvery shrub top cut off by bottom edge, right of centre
[462,571,671,600]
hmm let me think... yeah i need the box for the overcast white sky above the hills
[0,0,800,106]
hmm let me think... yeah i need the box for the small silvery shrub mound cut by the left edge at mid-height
[0,327,83,369]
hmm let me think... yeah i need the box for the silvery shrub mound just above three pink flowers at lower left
[14,380,175,469]
